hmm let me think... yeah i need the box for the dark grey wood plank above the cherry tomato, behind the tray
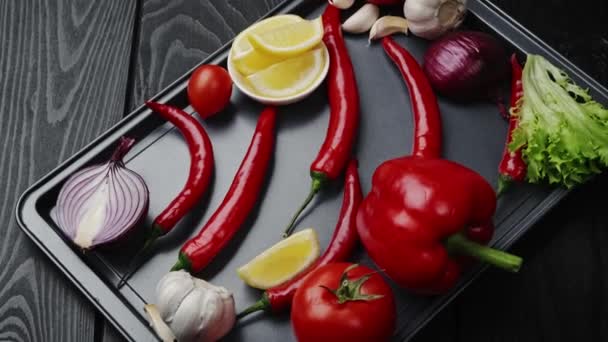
[129,0,282,109]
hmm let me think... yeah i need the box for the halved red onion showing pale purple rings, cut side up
[51,137,149,249]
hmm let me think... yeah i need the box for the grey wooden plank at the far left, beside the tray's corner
[0,0,135,342]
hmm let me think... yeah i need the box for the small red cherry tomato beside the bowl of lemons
[188,64,232,119]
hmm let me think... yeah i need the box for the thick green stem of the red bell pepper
[446,234,522,272]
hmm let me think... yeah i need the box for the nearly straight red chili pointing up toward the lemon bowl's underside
[171,107,276,273]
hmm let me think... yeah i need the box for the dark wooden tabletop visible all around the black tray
[0,0,608,342]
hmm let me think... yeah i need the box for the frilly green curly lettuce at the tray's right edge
[509,55,608,188]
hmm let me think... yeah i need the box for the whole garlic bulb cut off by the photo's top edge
[403,0,467,39]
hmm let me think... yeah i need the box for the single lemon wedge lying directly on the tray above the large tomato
[237,228,320,290]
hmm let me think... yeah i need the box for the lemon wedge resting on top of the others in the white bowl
[247,18,323,57]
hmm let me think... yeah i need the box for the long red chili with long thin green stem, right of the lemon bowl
[283,5,359,236]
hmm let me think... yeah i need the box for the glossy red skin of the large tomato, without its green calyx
[291,263,396,342]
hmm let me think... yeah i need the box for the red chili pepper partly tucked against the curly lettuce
[497,54,527,196]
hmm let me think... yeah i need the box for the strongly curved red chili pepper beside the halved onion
[118,101,214,288]
